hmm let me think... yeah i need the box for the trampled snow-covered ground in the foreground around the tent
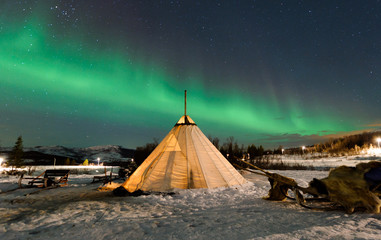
[0,159,381,239]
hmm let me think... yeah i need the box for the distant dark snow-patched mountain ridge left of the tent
[0,145,135,164]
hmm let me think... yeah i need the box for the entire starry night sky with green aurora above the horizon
[0,0,381,148]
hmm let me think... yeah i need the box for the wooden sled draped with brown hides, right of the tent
[241,160,381,213]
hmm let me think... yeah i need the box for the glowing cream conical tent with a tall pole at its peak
[122,91,246,192]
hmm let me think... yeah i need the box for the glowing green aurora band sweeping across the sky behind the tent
[0,1,378,148]
